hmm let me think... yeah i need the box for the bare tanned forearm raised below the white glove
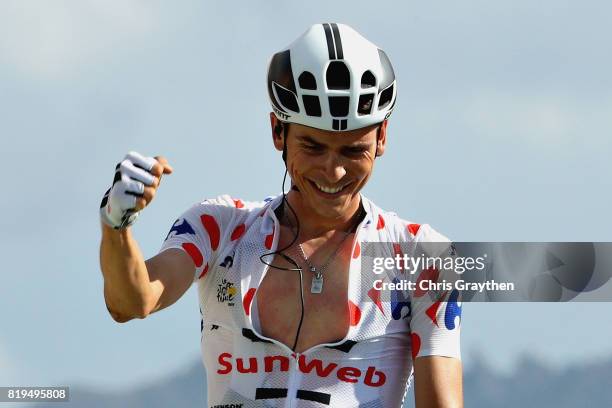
[100,224,151,321]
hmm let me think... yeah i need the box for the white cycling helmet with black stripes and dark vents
[268,23,397,131]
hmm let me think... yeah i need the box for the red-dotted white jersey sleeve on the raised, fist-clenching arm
[159,196,238,282]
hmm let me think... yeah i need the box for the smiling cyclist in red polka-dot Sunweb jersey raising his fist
[100,23,462,408]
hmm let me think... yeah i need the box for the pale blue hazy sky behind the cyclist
[0,0,612,388]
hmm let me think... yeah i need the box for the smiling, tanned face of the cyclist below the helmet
[275,115,386,219]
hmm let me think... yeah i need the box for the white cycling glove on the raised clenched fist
[100,152,157,229]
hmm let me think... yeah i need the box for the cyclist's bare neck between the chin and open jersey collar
[281,190,364,239]
